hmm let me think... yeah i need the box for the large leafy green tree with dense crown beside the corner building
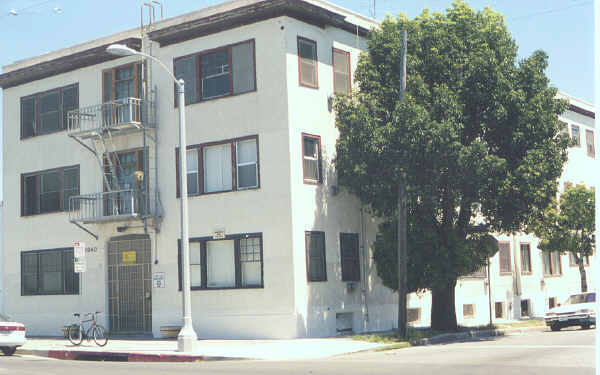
[335,1,569,330]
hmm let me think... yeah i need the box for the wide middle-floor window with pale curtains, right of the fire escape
[175,135,259,196]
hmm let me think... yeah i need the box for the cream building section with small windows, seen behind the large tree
[409,94,597,326]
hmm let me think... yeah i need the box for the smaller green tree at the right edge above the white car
[531,185,595,292]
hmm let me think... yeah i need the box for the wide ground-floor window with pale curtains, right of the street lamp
[179,233,263,290]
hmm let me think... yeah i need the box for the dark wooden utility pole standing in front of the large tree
[398,30,408,337]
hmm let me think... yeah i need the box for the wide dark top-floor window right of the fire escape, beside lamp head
[173,40,256,105]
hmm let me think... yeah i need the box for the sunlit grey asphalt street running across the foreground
[0,330,595,375]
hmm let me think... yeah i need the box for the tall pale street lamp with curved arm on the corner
[106,44,198,352]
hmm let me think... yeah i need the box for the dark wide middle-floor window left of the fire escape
[21,166,79,216]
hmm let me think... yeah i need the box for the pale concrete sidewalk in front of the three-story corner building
[17,338,385,362]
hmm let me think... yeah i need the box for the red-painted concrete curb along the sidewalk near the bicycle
[16,349,252,362]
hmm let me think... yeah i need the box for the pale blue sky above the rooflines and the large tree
[0,0,594,194]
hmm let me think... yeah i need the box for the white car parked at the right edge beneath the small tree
[545,292,596,331]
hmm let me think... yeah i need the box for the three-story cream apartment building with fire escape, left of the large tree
[0,0,404,338]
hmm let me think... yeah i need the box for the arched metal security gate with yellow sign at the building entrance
[108,235,152,334]
